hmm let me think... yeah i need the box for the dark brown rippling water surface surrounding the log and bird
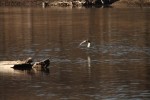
[0,8,150,100]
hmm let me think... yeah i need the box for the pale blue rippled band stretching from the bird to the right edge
[91,44,150,57]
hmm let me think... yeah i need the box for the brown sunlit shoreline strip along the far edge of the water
[0,0,150,8]
